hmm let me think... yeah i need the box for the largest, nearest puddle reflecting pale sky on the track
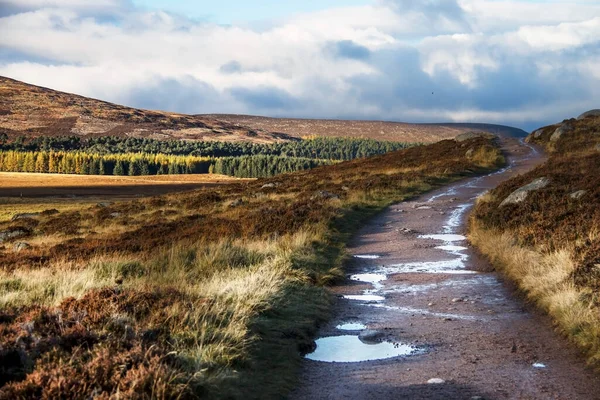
[306,335,418,362]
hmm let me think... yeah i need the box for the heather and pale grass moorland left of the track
[0,138,503,399]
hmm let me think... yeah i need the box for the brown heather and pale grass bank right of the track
[470,112,600,367]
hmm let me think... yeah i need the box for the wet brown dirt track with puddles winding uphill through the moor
[291,141,600,399]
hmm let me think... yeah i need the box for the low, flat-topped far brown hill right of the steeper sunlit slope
[206,114,527,143]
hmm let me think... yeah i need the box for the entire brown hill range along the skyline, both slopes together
[0,76,526,143]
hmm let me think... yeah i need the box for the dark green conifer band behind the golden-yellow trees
[0,136,415,160]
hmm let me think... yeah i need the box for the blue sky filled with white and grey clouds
[0,0,600,131]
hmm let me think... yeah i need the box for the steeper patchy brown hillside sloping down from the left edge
[0,77,290,143]
